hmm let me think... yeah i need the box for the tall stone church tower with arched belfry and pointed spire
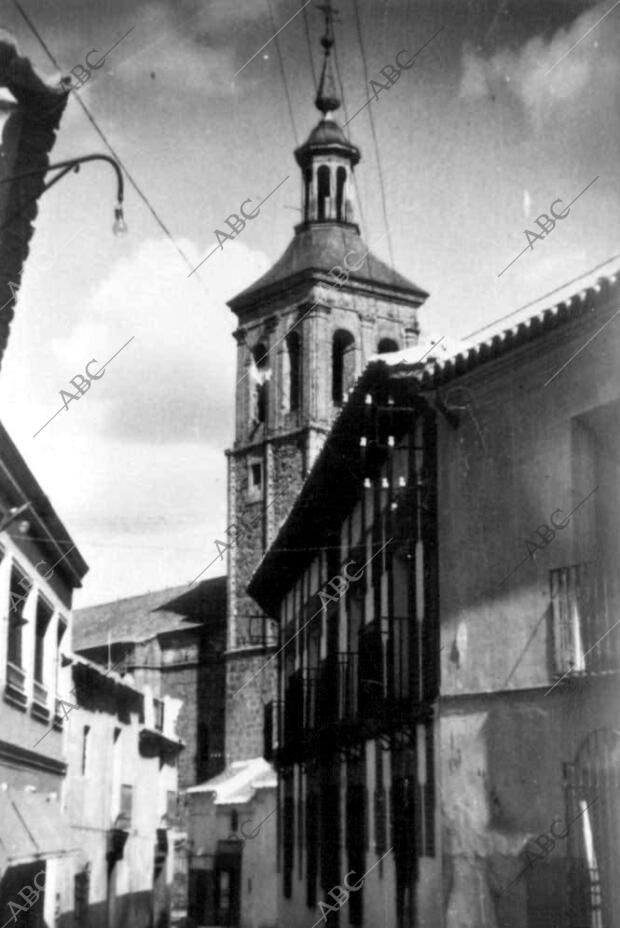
[226,3,428,761]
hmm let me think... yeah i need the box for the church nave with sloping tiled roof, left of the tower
[74,577,226,912]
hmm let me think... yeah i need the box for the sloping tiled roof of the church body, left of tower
[73,577,226,651]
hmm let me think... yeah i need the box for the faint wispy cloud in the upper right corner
[460,4,620,123]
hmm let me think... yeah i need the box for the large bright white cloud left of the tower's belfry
[41,240,268,447]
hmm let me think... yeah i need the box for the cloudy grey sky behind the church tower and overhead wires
[0,0,620,607]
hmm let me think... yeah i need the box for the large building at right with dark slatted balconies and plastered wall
[249,275,620,928]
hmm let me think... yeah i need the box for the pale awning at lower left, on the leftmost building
[0,789,80,873]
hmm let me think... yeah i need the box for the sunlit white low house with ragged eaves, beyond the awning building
[58,656,183,928]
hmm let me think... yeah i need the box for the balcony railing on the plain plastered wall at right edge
[549,564,620,675]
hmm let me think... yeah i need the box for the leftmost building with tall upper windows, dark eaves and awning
[0,425,88,926]
